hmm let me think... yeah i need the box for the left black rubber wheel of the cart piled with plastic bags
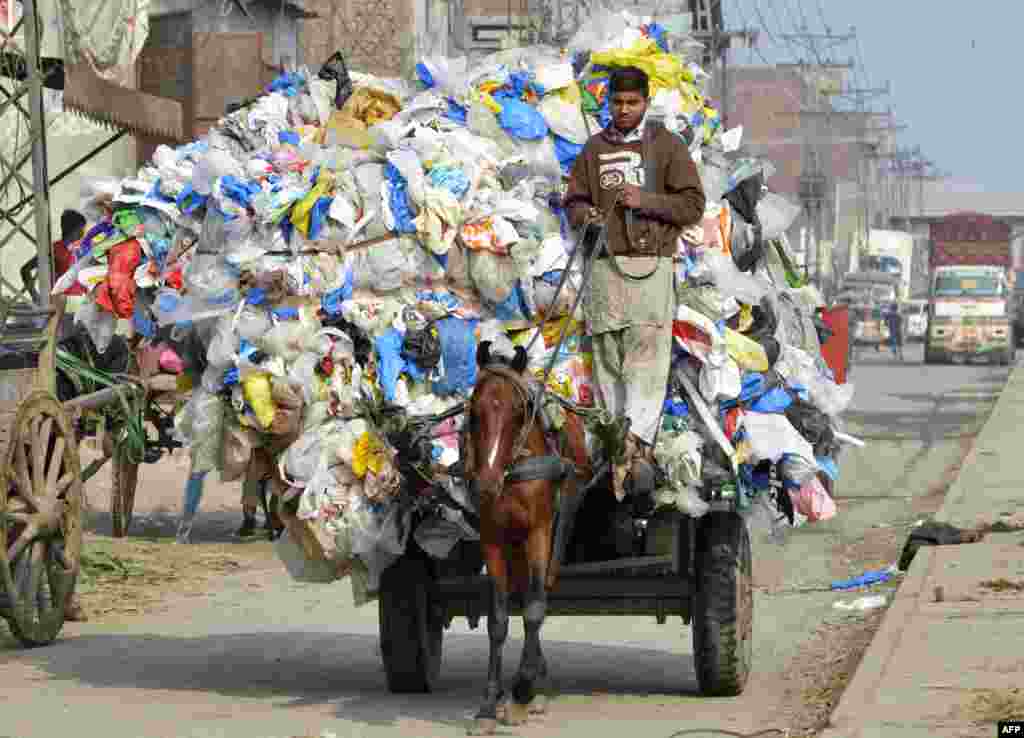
[380,555,444,694]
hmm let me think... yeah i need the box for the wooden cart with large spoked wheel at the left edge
[0,300,180,646]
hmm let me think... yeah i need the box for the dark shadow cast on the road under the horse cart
[0,631,697,727]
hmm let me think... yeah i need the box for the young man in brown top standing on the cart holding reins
[564,67,705,506]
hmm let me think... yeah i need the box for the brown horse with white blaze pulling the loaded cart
[464,342,586,735]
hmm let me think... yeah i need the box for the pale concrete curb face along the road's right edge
[818,367,1024,738]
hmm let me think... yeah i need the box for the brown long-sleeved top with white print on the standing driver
[564,123,705,256]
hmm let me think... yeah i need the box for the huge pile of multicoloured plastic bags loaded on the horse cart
[55,5,851,601]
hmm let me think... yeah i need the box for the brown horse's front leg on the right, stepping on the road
[508,521,551,725]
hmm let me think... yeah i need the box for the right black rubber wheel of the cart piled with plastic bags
[693,513,754,697]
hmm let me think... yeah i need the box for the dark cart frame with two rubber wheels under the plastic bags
[379,366,754,696]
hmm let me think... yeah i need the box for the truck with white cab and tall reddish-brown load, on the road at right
[925,213,1016,364]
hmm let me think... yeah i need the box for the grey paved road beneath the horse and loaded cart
[0,347,1007,738]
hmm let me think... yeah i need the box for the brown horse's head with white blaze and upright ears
[464,341,534,496]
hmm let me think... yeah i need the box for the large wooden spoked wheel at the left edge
[0,391,82,647]
